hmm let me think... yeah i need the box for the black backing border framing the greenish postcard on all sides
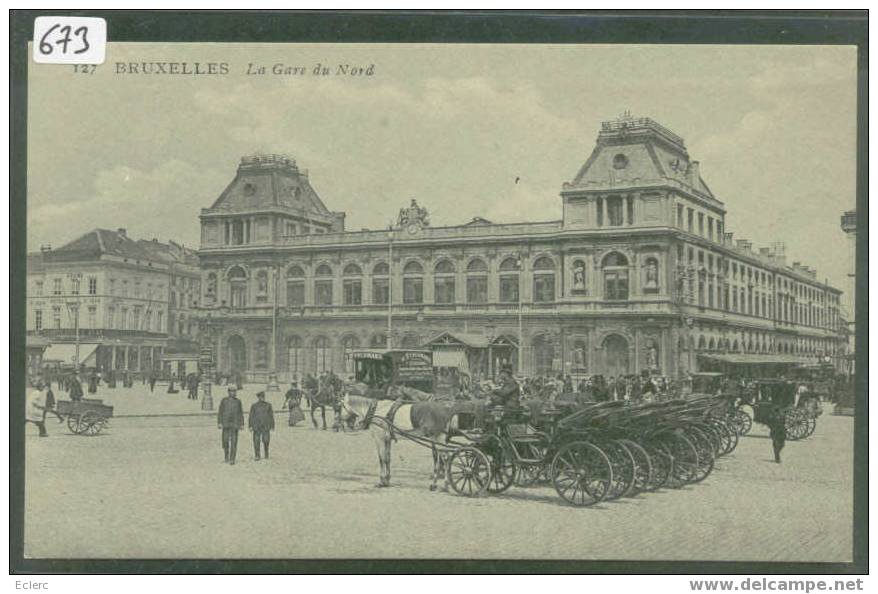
[9,10,869,575]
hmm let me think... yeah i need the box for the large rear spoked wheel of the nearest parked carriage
[552,441,613,507]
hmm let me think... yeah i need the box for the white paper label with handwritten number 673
[33,17,107,64]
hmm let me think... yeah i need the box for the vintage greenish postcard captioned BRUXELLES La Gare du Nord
[13,12,858,564]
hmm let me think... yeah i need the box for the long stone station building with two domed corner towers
[198,117,845,377]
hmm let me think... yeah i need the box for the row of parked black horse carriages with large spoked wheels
[434,397,749,506]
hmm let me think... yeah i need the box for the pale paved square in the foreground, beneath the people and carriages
[25,398,853,561]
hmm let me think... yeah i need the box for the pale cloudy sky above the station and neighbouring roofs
[27,43,856,302]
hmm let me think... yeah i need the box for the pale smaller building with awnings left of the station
[27,229,201,371]
